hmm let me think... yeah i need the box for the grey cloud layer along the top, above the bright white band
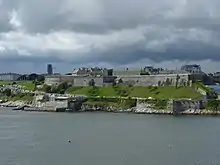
[3,0,220,33]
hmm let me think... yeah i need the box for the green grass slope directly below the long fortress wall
[67,86,201,99]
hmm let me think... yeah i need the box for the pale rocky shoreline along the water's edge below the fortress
[0,100,220,116]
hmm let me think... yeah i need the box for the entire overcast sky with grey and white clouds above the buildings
[0,0,220,72]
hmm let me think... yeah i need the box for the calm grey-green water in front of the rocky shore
[0,109,220,165]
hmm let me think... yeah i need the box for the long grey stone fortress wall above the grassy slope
[45,74,189,86]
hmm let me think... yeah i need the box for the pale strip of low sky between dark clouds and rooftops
[0,61,220,74]
